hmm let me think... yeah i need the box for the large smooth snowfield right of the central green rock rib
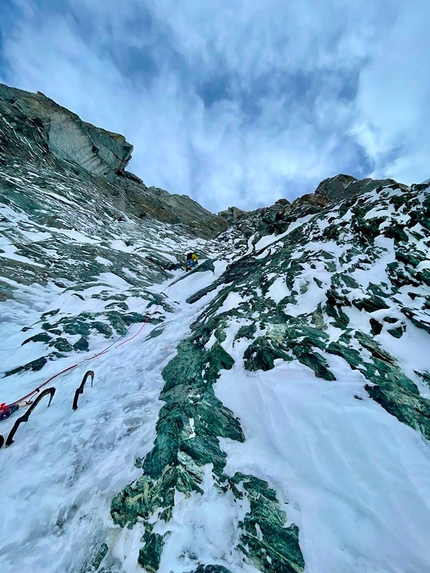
[216,360,430,573]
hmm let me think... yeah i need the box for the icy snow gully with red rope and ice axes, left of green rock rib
[0,265,225,573]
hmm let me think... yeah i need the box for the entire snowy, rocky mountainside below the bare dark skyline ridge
[0,180,430,573]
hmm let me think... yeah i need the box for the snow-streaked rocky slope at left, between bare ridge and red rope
[0,156,227,382]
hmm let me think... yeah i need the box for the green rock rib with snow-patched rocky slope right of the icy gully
[112,187,430,573]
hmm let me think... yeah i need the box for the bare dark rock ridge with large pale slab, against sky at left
[0,84,228,238]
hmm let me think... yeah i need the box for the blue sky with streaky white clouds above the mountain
[0,0,430,212]
